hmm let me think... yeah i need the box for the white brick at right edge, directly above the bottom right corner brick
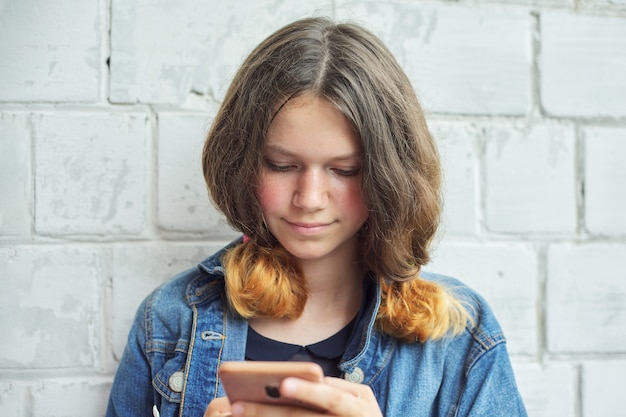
[546,243,626,353]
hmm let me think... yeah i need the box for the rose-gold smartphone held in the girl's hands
[219,361,324,409]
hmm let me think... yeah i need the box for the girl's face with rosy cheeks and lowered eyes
[257,95,367,262]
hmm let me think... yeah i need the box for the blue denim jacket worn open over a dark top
[106,242,526,417]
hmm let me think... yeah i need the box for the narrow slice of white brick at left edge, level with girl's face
[0,113,32,236]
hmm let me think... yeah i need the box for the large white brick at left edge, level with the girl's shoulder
[0,246,102,369]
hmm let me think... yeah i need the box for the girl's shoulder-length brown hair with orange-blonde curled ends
[202,18,469,341]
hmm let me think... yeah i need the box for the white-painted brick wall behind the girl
[0,0,626,417]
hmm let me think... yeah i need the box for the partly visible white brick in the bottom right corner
[582,360,626,417]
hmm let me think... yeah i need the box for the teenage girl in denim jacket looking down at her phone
[107,18,526,417]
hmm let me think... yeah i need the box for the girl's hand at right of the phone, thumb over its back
[224,377,382,417]
